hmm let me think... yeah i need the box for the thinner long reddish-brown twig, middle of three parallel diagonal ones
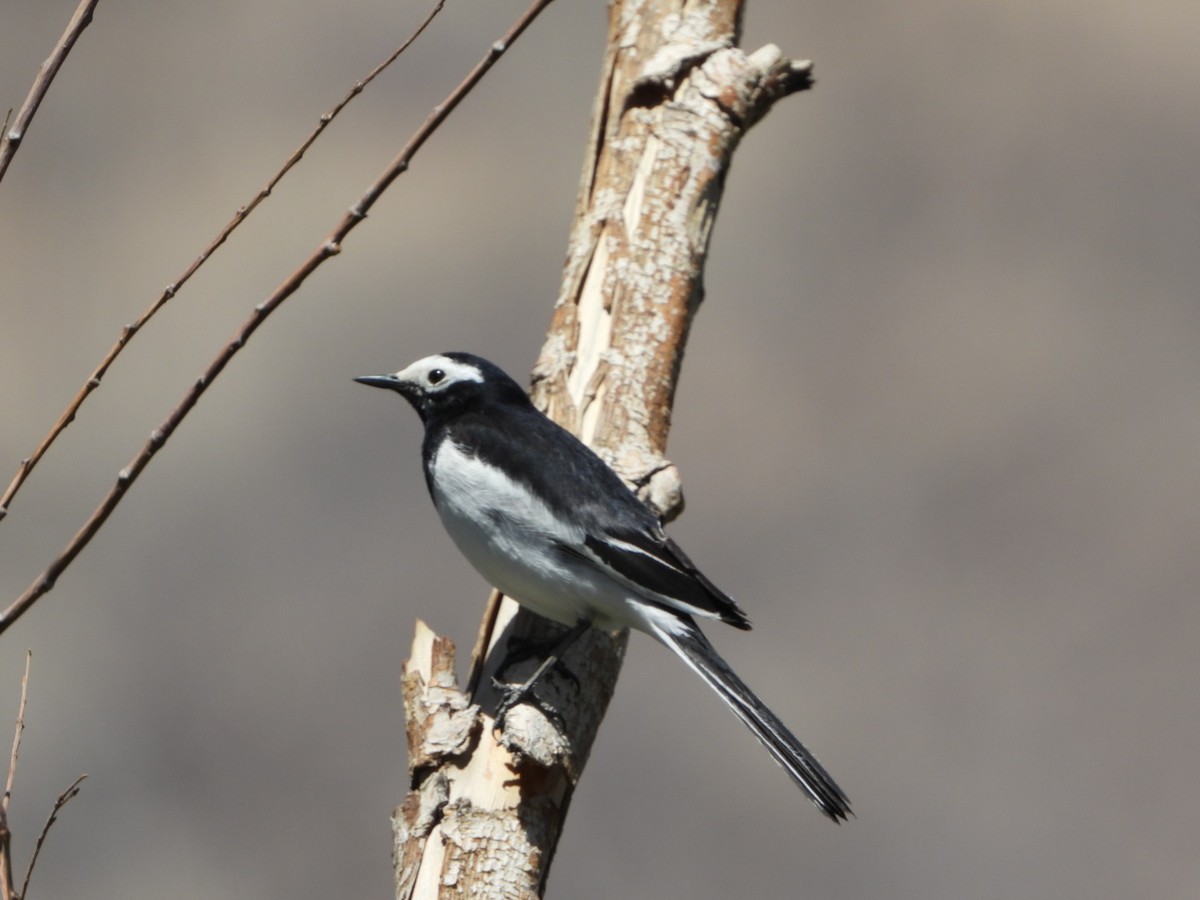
[0,0,445,520]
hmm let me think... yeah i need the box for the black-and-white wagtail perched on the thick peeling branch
[354,352,853,822]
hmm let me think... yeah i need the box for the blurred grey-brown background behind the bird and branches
[0,0,1200,900]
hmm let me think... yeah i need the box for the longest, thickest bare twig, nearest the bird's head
[0,0,553,634]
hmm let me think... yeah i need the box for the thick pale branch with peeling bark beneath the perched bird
[394,0,811,898]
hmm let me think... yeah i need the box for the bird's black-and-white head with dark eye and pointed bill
[354,353,528,421]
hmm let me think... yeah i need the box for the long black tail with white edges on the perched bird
[653,612,853,822]
